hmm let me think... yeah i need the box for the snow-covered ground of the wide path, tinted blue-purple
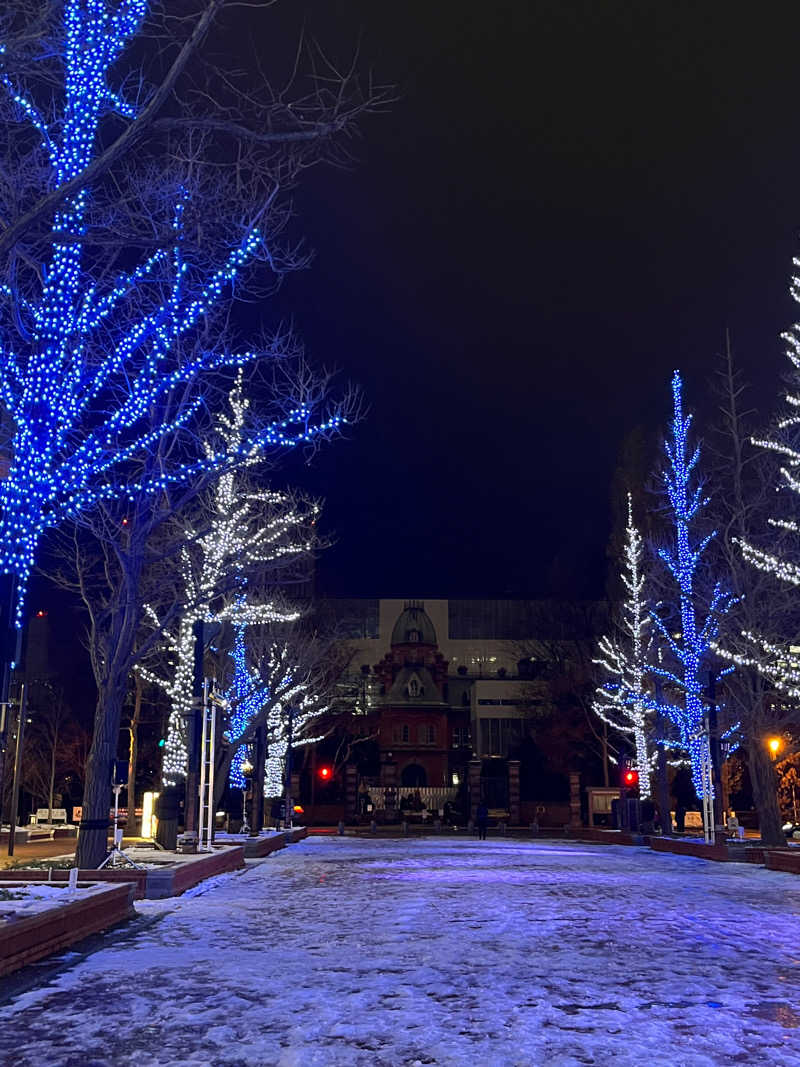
[0,837,800,1067]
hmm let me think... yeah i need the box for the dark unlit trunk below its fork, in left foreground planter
[76,679,126,870]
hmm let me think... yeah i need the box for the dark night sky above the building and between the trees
[243,0,800,596]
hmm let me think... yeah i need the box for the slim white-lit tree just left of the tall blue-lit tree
[592,493,655,796]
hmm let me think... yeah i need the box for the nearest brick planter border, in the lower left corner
[0,879,134,975]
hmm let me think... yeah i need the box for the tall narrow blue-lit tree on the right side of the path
[652,371,734,797]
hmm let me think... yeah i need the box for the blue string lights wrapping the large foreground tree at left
[0,0,345,626]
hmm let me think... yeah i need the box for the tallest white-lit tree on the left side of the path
[139,373,319,785]
